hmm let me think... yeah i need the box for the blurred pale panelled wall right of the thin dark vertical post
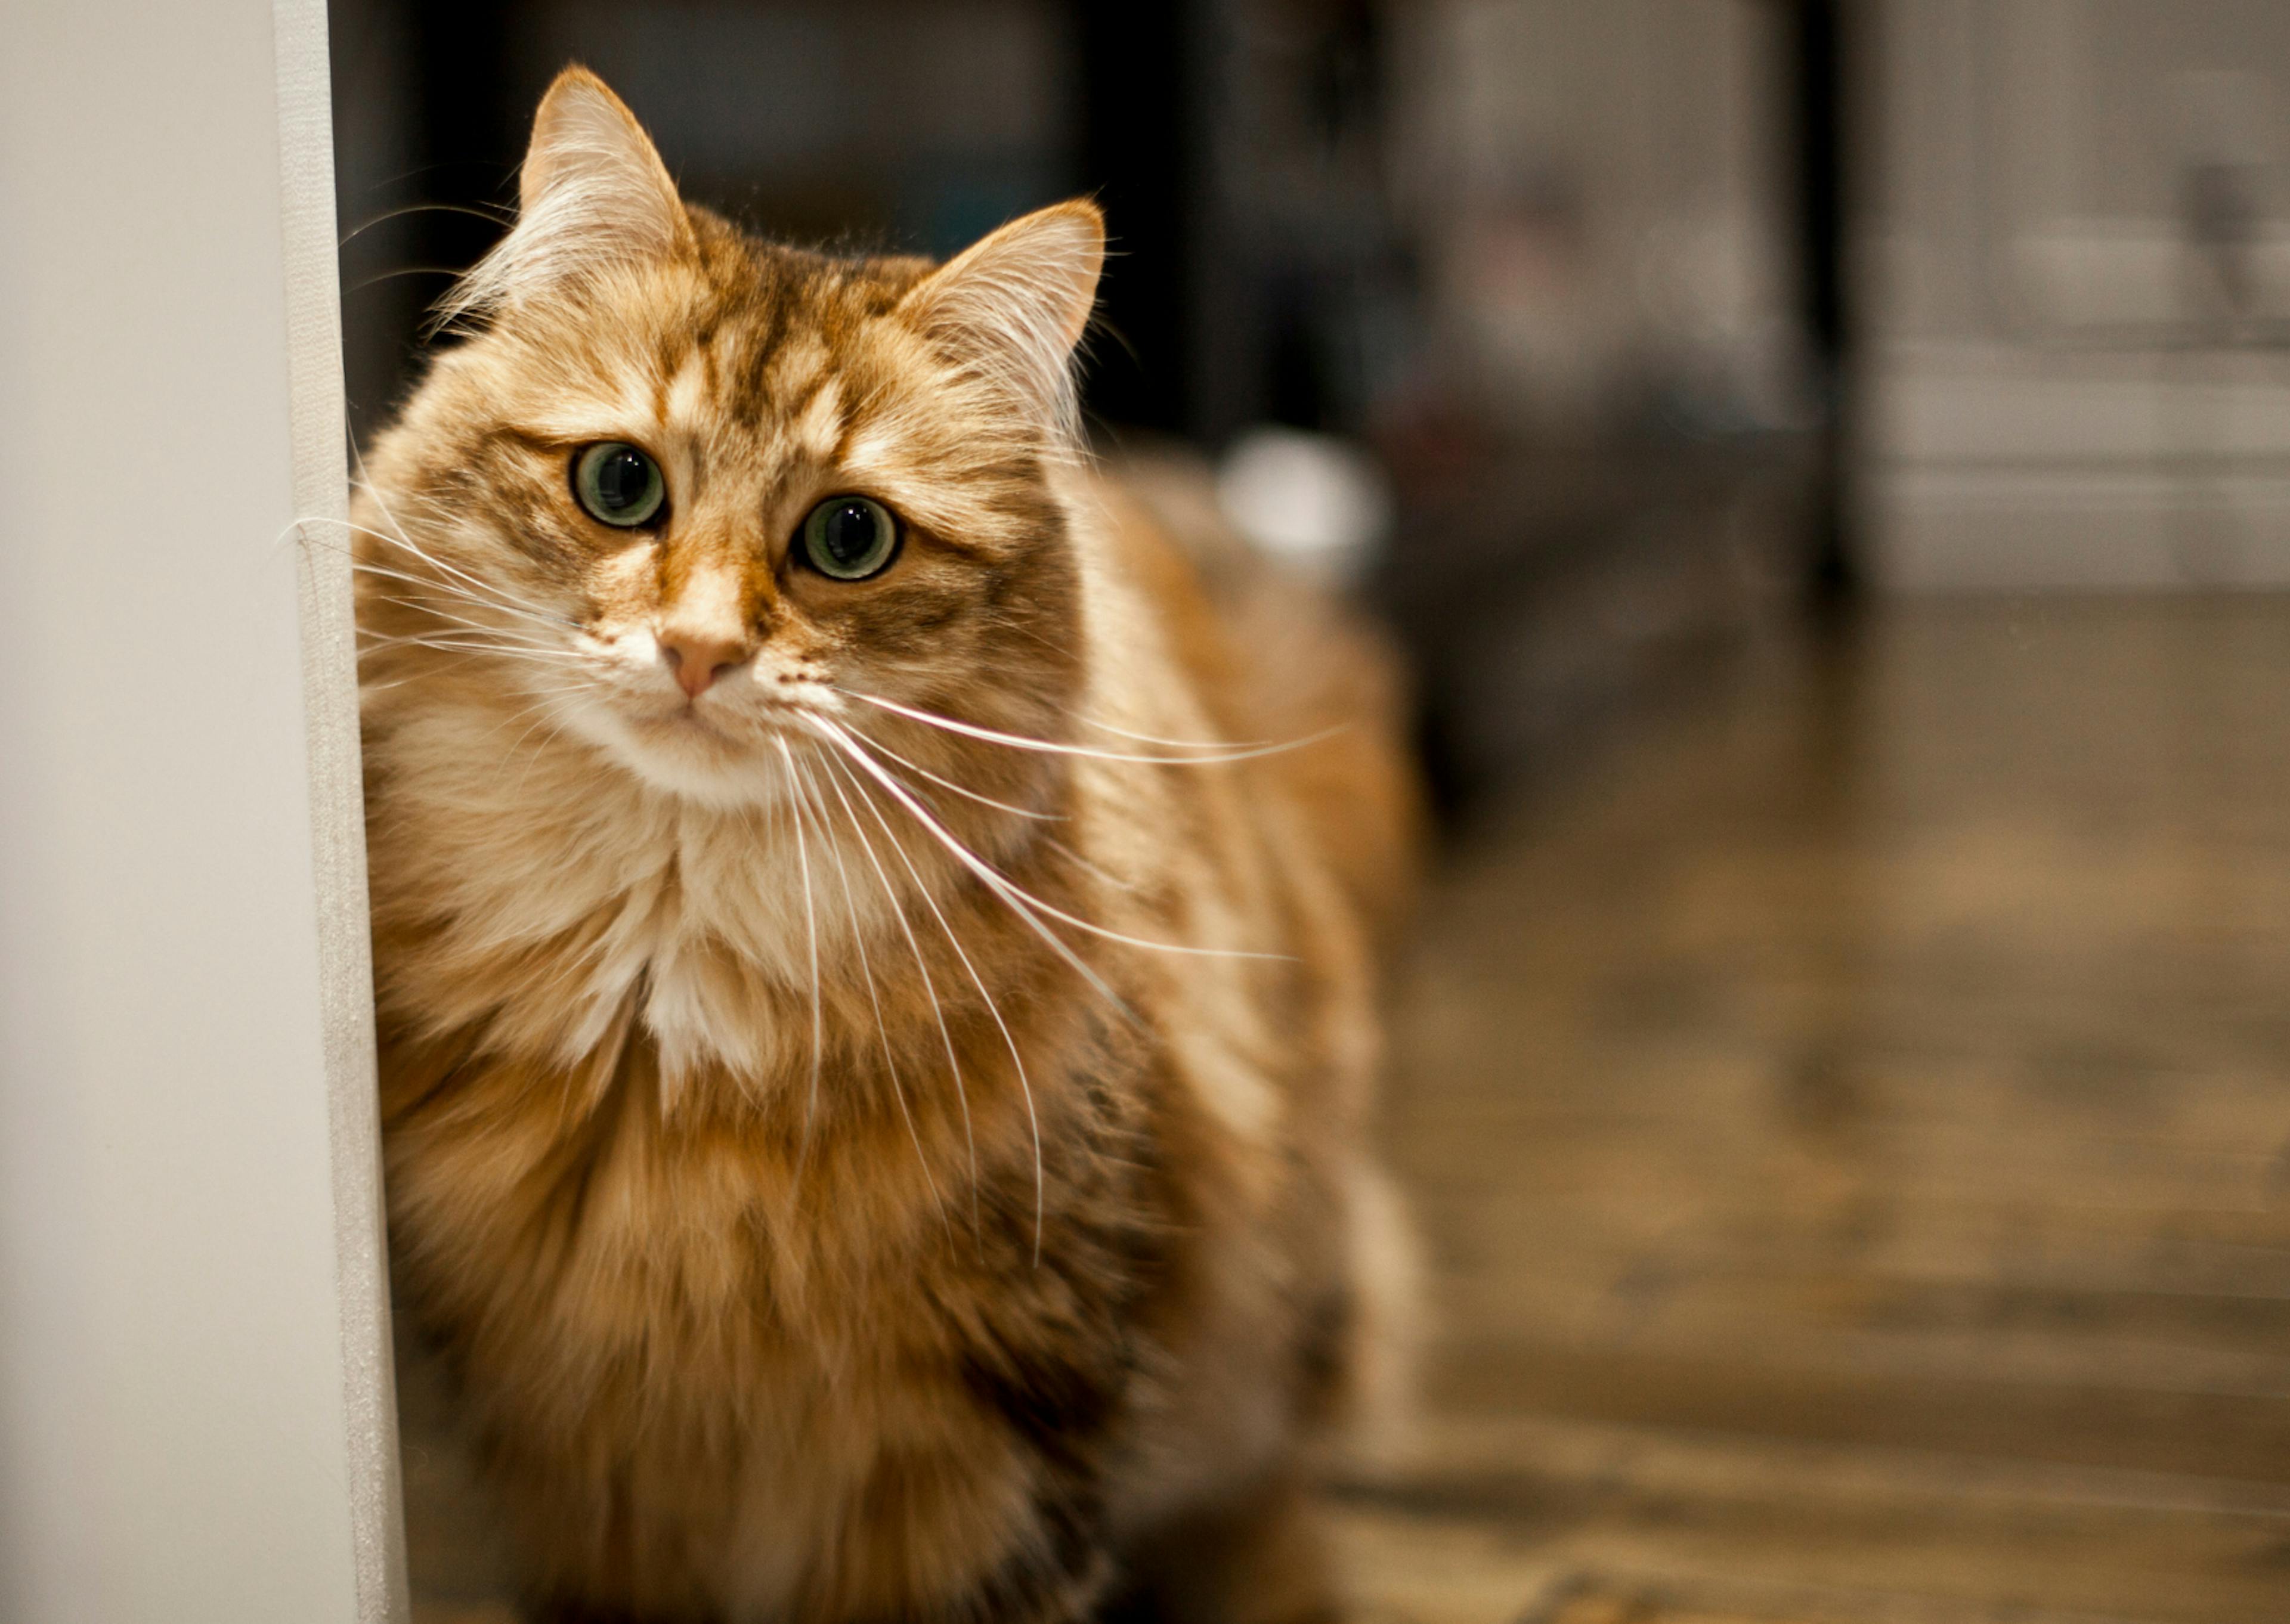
[1857,0,2290,591]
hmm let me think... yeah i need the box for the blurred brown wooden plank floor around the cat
[408,600,2290,1624]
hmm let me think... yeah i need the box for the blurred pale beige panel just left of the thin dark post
[1401,0,1802,438]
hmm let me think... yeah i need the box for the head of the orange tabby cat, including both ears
[360,69,1104,804]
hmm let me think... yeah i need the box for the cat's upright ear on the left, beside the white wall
[440,66,694,321]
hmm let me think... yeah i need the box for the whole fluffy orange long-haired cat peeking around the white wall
[357,71,1410,1624]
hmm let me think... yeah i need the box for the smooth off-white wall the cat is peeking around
[0,0,394,1624]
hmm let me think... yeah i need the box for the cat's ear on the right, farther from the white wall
[898,197,1106,435]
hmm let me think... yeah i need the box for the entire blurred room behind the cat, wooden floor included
[332,0,2290,1624]
